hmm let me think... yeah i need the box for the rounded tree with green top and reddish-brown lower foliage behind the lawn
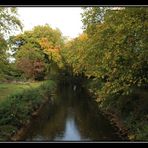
[16,44,46,80]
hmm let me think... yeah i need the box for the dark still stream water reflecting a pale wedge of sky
[24,87,121,141]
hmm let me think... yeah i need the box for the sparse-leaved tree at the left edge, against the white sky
[0,7,22,81]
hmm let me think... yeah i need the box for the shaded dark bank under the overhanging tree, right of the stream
[85,81,148,141]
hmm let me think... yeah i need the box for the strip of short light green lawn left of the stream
[0,81,44,102]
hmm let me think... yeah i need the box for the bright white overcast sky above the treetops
[18,7,82,38]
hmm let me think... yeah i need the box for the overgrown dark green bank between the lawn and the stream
[0,81,55,141]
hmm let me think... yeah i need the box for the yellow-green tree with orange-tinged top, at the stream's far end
[62,33,88,75]
